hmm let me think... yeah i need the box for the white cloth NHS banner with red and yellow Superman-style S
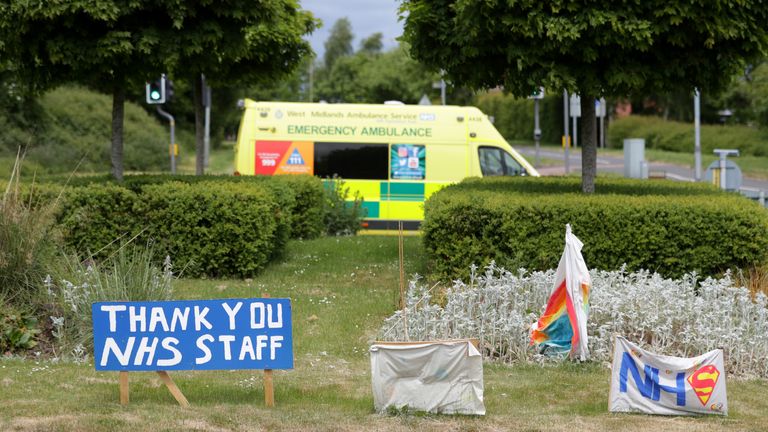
[609,337,728,415]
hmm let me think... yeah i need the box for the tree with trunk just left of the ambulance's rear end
[171,0,317,175]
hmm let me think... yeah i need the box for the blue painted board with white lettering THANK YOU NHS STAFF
[91,298,293,371]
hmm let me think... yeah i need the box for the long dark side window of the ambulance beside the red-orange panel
[315,142,389,180]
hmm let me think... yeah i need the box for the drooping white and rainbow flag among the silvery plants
[531,225,592,361]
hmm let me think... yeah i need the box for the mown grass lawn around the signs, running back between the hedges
[0,236,768,432]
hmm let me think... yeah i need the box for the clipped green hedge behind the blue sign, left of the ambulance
[13,176,325,277]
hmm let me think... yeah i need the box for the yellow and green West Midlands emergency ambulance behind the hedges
[235,99,539,229]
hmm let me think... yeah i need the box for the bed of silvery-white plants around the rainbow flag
[379,263,768,377]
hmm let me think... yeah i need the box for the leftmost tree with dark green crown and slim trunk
[0,0,174,180]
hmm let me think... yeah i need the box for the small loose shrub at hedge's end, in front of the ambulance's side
[323,177,363,235]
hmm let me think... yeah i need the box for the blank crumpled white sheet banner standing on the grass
[370,340,485,415]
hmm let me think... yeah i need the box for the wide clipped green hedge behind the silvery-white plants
[422,178,768,277]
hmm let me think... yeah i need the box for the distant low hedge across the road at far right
[607,116,768,156]
